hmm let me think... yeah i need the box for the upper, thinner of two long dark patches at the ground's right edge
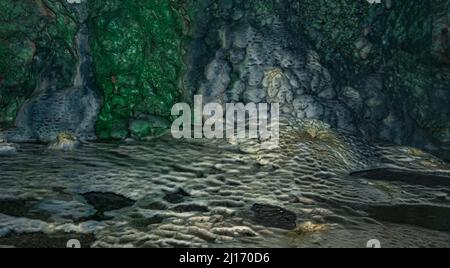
[350,168,450,186]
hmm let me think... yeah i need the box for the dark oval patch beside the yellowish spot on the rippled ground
[251,204,297,230]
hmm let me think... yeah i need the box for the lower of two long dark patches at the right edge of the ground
[368,205,450,232]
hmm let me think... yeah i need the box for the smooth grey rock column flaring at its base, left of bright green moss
[2,2,100,142]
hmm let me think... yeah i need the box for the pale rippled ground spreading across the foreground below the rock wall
[0,122,450,247]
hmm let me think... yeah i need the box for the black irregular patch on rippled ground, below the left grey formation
[82,192,136,221]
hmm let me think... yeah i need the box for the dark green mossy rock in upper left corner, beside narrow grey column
[0,0,76,126]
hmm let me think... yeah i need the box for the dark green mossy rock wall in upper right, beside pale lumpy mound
[292,0,450,146]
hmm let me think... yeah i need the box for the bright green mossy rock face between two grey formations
[90,0,185,139]
